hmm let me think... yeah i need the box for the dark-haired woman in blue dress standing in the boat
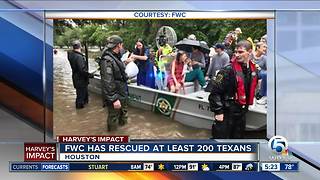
[130,38,155,88]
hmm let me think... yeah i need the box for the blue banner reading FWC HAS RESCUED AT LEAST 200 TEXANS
[59,143,258,153]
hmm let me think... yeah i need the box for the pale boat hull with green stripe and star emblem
[89,78,266,130]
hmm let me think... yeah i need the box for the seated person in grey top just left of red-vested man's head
[206,43,230,79]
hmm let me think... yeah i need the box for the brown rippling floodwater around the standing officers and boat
[53,50,211,139]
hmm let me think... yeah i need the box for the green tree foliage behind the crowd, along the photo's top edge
[54,19,266,50]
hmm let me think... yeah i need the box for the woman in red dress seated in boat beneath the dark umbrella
[168,51,189,93]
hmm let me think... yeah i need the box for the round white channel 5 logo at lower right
[268,136,288,155]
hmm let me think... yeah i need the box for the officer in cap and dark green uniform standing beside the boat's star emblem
[100,35,128,131]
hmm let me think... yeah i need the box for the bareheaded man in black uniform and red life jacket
[209,40,258,139]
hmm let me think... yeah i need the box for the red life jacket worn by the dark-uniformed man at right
[231,58,258,105]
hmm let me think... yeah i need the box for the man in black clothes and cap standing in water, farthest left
[68,40,93,109]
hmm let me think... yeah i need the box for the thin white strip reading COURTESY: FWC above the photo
[46,11,274,19]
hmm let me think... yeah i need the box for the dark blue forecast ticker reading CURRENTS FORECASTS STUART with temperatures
[9,162,258,172]
